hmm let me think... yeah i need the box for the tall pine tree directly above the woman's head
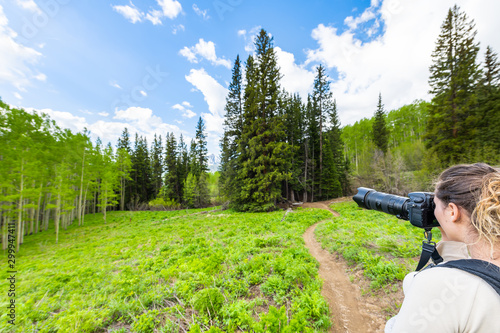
[426,5,479,166]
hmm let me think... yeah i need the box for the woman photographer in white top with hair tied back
[385,163,500,333]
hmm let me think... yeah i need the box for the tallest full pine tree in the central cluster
[236,29,289,211]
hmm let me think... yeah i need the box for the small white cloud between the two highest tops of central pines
[274,47,315,100]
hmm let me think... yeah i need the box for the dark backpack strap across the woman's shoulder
[440,259,500,296]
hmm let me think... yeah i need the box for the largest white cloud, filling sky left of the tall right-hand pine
[306,0,500,125]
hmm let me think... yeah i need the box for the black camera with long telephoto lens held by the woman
[353,187,439,230]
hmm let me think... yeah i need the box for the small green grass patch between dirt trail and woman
[316,202,440,289]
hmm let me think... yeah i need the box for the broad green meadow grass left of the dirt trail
[0,209,331,332]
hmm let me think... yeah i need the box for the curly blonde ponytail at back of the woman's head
[471,170,500,258]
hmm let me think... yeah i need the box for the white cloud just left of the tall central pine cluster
[186,68,228,133]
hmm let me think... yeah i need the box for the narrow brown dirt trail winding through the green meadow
[302,201,385,333]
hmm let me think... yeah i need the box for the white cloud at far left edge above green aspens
[0,5,45,91]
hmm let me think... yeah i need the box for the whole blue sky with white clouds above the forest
[0,0,500,155]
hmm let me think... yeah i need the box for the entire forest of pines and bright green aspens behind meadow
[0,6,500,251]
